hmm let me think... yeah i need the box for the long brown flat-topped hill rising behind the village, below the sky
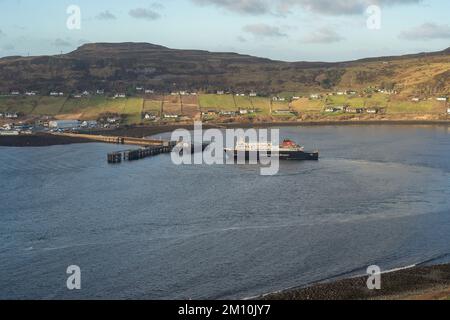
[0,43,450,95]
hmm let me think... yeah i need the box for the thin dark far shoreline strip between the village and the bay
[0,120,450,147]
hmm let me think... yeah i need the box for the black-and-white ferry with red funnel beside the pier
[225,139,319,161]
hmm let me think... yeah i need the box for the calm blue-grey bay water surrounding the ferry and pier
[0,126,450,299]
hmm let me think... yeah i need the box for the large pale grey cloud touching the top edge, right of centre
[191,0,422,15]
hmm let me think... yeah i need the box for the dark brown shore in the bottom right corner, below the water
[263,265,450,300]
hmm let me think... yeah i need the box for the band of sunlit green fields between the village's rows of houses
[0,94,446,124]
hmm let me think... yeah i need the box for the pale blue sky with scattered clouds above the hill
[0,0,450,61]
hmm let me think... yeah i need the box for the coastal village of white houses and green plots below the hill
[0,86,450,135]
